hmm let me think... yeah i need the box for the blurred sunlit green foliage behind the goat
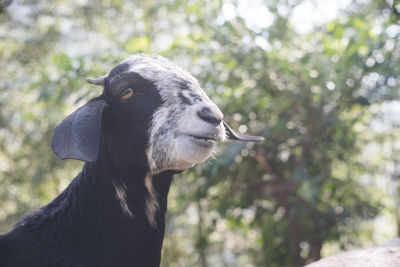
[0,0,400,267]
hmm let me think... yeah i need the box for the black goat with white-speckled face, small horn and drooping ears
[0,54,263,267]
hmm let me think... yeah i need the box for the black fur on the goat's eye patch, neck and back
[0,64,174,267]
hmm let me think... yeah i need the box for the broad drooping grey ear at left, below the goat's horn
[51,99,108,162]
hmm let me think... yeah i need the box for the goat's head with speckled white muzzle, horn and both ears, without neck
[53,54,261,174]
